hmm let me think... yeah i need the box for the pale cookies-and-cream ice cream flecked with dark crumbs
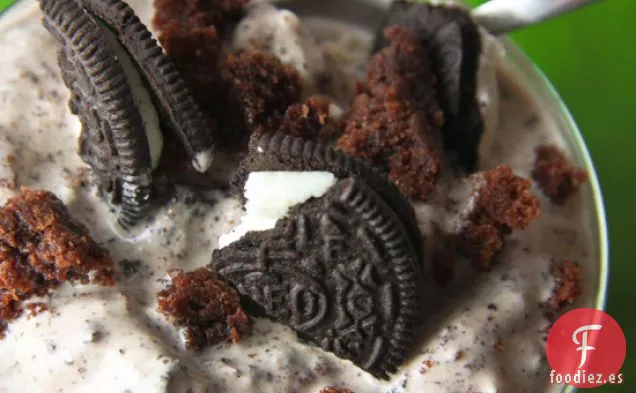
[0,0,594,393]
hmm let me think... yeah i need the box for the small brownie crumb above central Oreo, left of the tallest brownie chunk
[278,97,340,145]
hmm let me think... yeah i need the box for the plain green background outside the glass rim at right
[0,0,636,393]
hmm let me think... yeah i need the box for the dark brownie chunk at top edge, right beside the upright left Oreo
[153,0,248,147]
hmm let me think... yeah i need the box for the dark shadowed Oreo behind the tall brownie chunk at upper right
[374,0,484,171]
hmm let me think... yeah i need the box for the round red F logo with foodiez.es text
[546,308,627,388]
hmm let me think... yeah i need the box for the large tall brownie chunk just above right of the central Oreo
[336,27,444,199]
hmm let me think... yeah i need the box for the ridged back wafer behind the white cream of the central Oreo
[231,133,422,258]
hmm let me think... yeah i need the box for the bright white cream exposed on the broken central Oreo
[219,171,336,248]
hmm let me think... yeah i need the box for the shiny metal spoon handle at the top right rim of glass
[472,0,598,34]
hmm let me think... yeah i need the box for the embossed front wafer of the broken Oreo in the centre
[212,177,421,378]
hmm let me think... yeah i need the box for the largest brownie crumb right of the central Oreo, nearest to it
[461,165,541,269]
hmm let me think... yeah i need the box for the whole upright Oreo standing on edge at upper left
[40,0,213,227]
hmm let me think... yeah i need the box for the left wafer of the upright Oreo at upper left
[40,0,152,226]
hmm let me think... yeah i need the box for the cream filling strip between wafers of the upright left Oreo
[98,21,163,169]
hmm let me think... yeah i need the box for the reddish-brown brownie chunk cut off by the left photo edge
[0,188,115,336]
